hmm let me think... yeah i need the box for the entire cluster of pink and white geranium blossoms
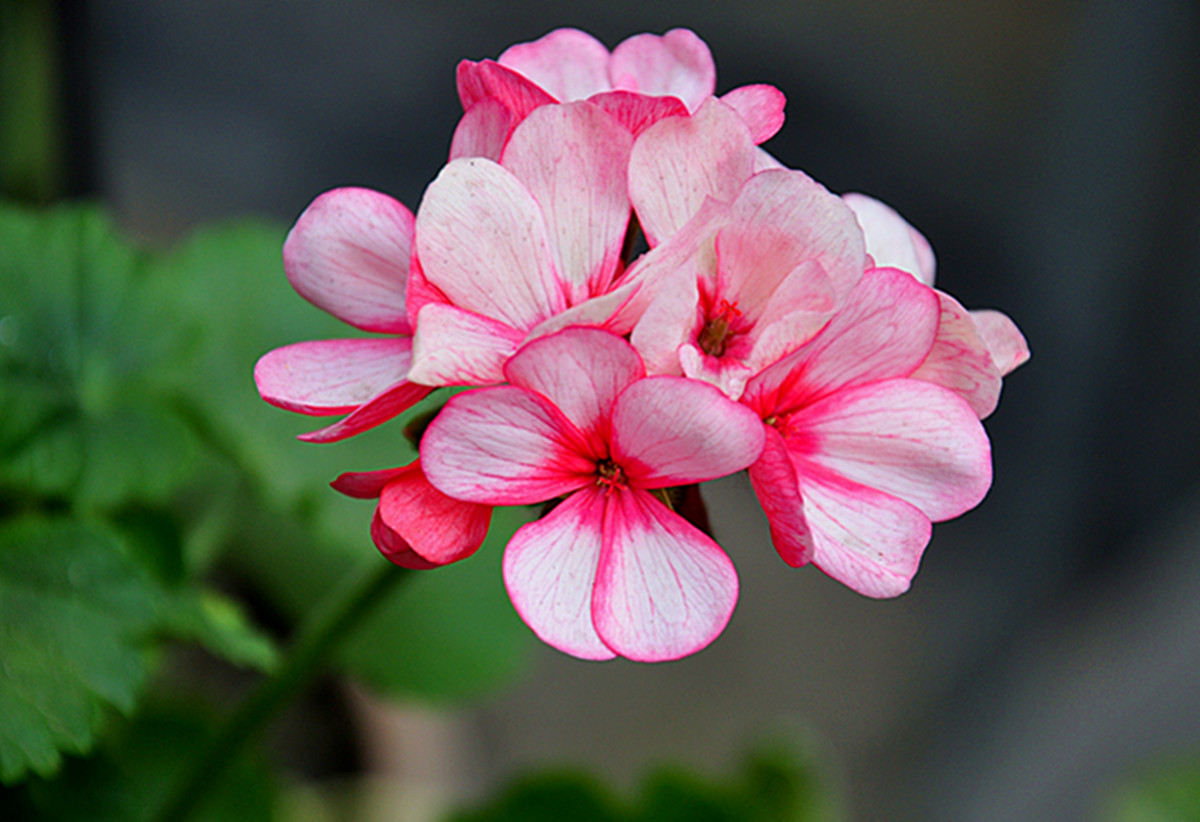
[254,29,1028,661]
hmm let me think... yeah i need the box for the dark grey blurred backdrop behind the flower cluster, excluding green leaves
[28,0,1200,822]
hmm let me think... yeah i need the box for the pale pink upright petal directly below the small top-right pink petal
[629,100,756,247]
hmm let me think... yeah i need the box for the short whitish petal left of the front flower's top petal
[408,302,524,385]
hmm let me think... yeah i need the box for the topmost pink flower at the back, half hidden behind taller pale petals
[450,29,786,160]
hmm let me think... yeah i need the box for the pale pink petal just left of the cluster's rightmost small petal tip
[910,292,1001,420]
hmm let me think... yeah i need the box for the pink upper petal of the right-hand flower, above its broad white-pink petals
[743,269,938,415]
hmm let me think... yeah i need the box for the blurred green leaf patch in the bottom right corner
[1100,756,1200,822]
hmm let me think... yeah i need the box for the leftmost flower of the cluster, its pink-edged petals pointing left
[254,188,432,443]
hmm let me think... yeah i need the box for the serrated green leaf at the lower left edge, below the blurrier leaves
[0,517,158,784]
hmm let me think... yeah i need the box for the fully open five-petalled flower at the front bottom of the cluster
[421,328,763,661]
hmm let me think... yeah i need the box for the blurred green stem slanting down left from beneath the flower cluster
[152,557,408,822]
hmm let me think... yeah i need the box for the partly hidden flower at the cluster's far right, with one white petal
[842,193,1030,419]
